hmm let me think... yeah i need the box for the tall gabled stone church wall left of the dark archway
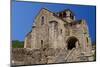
[29,9,65,49]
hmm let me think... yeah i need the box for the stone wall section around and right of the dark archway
[66,20,91,52]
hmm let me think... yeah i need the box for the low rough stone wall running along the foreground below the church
[11,48,94,65]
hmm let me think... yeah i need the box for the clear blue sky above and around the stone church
[11,1,96,41]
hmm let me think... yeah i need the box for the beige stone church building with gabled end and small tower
[24,8,91,51]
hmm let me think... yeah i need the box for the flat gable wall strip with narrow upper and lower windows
[33,10,49,48]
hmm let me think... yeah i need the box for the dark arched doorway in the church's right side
[66,37,79,50]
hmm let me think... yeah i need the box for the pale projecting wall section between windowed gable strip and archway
[49,16,65,48]
